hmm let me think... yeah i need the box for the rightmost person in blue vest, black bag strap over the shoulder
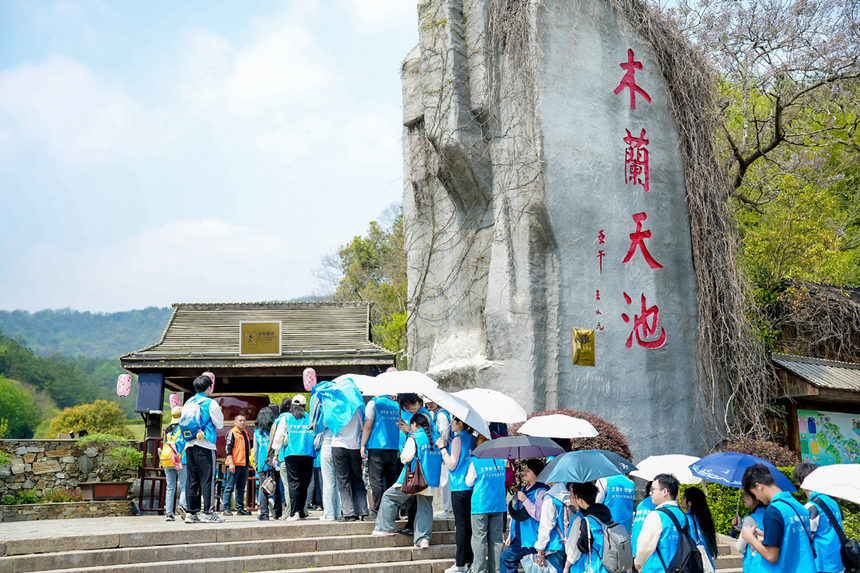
[791,462,845,573]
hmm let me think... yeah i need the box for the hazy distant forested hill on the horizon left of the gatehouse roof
[0,306,171,359]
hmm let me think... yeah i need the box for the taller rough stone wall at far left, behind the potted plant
[0,440,131,496]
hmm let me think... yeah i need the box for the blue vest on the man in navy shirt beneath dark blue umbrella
[762,491,816,573]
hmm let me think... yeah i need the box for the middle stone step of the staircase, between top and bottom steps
[0,531,454,573]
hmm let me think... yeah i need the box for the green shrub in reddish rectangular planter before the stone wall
[80,434,143,500]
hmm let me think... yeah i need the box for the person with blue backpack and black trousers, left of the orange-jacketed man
[179,372,224,523]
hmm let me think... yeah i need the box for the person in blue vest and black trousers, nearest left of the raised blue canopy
[276,394,316,521]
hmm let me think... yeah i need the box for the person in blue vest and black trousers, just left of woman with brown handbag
[361,396,400,519]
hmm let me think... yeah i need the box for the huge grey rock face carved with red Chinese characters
[403,0,704,457]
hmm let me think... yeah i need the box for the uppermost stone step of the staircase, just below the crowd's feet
[4,518,454,561]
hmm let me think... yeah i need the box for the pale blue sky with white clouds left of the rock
[0,0,418,311]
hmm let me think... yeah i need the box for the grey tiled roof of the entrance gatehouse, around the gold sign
[120,302,394,368]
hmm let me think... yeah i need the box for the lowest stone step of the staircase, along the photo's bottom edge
[31,545,455,573]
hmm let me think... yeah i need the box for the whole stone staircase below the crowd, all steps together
[0,518,454,573]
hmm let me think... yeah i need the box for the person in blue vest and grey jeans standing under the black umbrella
[466,436,507,573]
